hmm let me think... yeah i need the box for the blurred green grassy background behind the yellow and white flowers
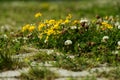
[0,0,120,30]
